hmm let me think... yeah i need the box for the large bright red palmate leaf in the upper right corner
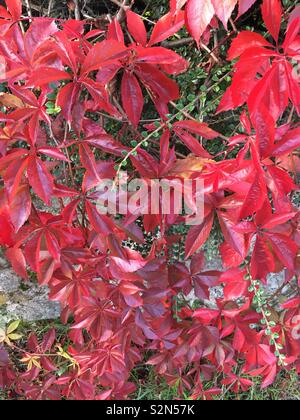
[219,0,300,120]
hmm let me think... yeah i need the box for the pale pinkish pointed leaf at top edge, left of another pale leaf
[185,0,215,47]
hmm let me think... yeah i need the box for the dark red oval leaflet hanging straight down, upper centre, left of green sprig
[122,71,144,128]
